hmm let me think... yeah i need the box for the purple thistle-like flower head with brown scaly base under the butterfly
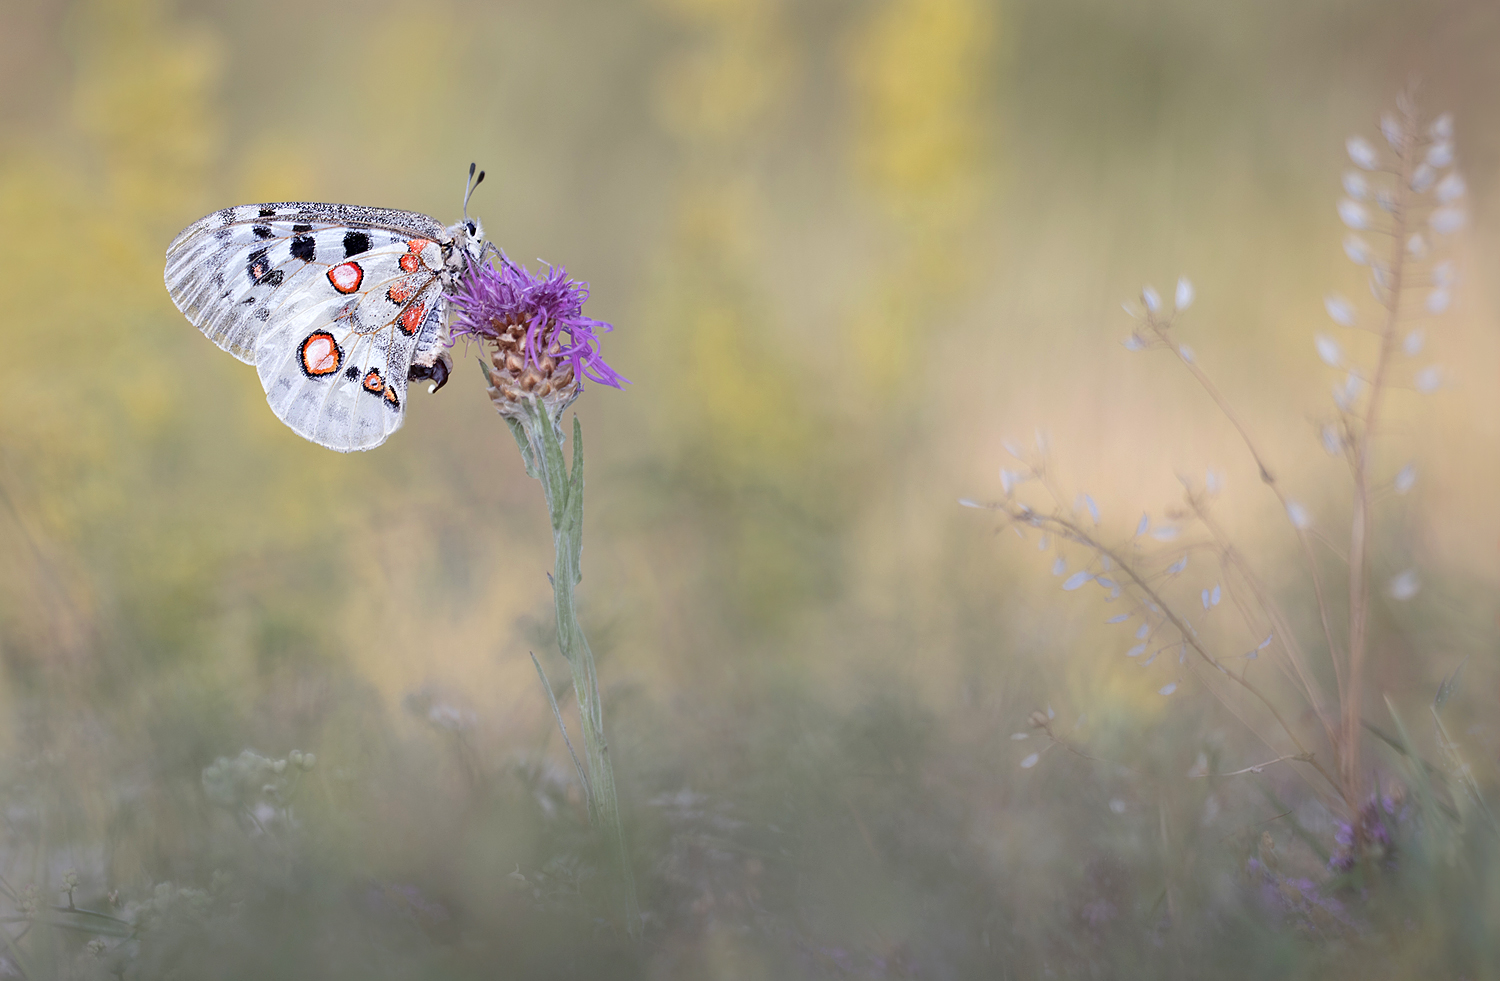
[452,255,629,416]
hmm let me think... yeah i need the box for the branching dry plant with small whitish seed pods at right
[960,96,1467,800]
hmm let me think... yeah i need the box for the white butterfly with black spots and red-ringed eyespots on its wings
[165,165,494,453]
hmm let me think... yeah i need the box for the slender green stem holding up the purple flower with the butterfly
[506,399,641,939]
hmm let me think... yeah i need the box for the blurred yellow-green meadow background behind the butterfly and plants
[0,0,1500,980]
